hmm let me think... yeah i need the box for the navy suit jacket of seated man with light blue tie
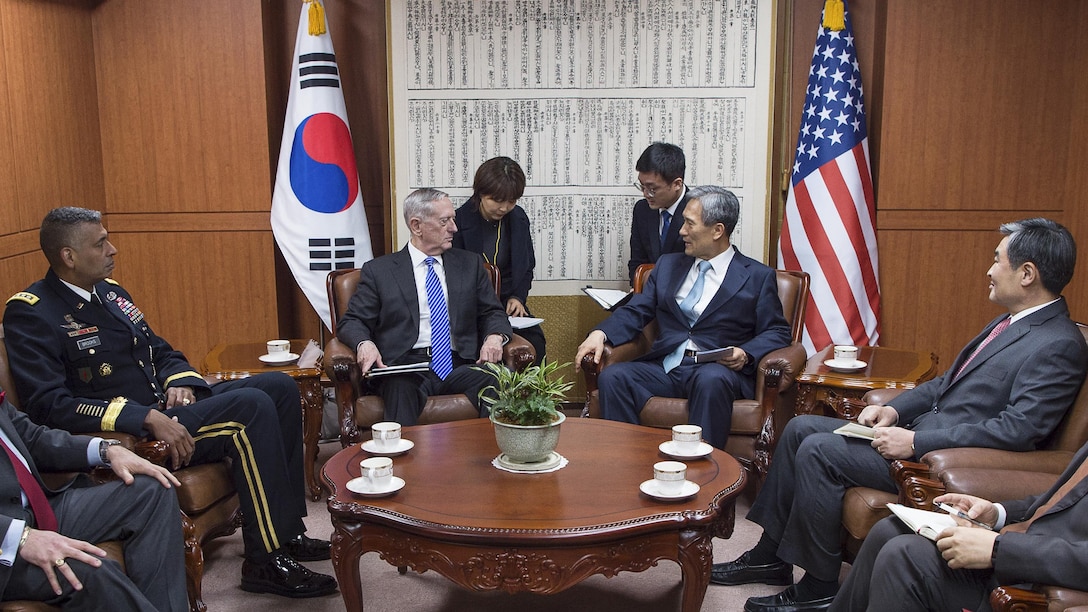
[597,246,790,375]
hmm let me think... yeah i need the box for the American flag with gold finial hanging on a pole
[778,0,880,355]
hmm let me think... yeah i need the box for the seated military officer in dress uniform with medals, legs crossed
[3,207,336,597]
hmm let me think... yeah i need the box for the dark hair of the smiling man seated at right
[1000,217,1077,295]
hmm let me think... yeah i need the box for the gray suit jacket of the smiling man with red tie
[889,298,1088,457]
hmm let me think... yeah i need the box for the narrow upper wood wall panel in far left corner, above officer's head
[0,0,104,233]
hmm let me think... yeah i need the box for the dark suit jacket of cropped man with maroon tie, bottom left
[0,389,91,595]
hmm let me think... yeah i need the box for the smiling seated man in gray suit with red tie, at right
[710,219,1088,612]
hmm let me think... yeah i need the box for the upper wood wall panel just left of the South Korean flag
[94,0,271,214]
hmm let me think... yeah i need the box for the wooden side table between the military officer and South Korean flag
[200,340,325,501]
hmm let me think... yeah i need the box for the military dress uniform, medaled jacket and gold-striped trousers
[3,270,306,561]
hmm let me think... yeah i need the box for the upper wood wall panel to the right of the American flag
[879,0,1083,210]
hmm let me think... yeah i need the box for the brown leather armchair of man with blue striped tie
[324,264,536,446]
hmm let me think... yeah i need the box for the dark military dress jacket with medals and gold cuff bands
[3,270,211,436]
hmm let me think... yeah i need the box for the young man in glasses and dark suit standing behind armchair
[627,143,688,284]
